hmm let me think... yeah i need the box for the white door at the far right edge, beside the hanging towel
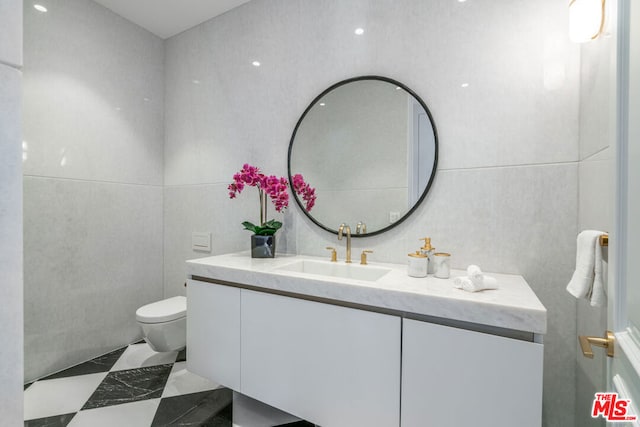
[594,0,640,426]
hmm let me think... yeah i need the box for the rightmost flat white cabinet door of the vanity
[401,319,543,427]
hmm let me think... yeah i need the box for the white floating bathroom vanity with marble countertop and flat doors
[187,253,546,427]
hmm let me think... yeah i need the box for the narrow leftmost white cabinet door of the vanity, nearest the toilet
[187,280,240,390]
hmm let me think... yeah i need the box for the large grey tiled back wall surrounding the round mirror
[165,0,580,426]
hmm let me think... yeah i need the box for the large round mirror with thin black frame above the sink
[288,76,438,237]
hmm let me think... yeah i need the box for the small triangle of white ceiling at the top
[95,0,249,39]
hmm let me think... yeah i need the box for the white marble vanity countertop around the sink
[187,252,547,334]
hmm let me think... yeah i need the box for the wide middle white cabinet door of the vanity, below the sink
[241,290,401,427]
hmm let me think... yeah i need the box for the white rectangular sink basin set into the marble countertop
[276,260,391,282]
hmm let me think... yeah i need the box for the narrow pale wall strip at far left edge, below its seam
[0,61,23,425]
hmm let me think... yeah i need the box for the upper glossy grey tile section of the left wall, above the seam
[24,0,164,185]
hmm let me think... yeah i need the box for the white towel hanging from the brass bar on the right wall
[567,230,606,307]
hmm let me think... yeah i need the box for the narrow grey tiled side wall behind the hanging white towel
[574,27,616,427]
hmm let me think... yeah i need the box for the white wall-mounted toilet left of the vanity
[136,296,187,352]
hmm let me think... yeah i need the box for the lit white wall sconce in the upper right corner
[569,0,605,43]
